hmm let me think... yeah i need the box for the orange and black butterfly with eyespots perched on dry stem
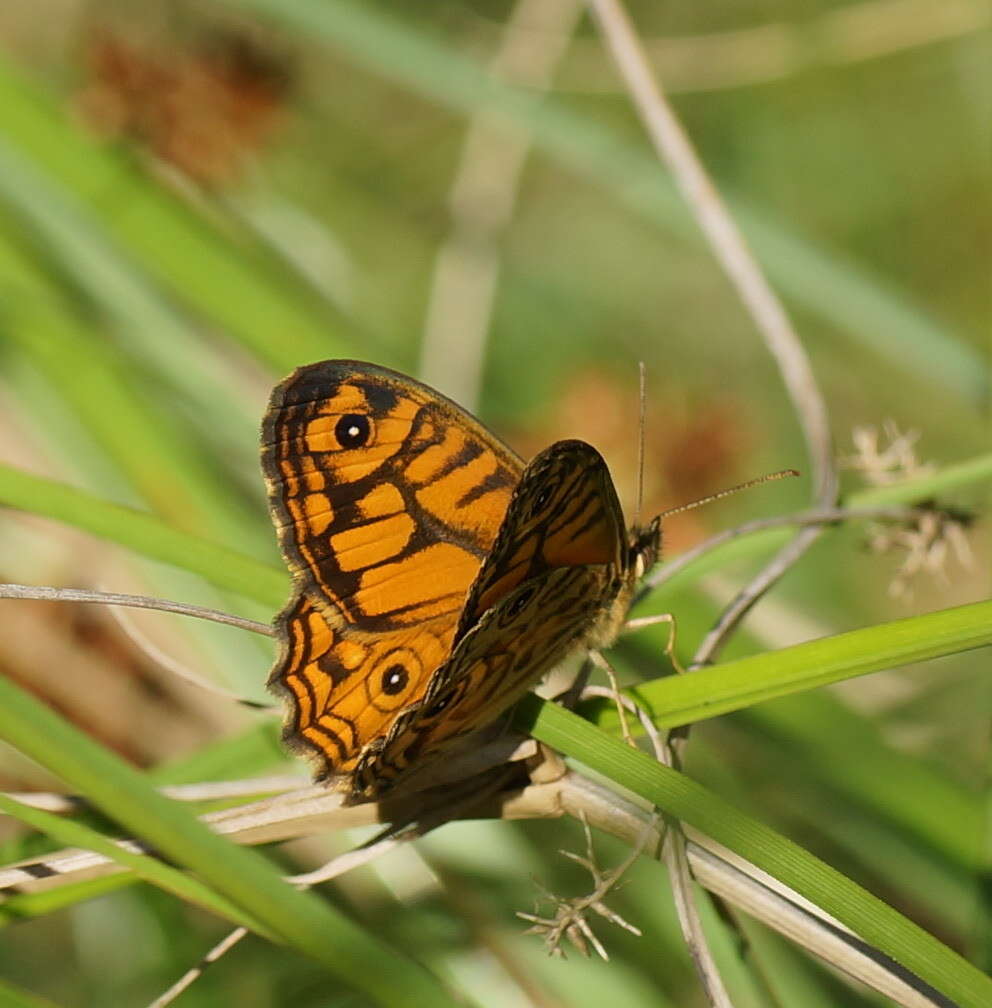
[261,360,660,803]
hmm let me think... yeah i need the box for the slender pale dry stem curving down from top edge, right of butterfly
[589,0,837,665]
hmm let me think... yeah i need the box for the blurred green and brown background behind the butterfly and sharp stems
[0,0,992,1008]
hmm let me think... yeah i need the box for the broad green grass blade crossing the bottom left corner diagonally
[0,679,453,1006]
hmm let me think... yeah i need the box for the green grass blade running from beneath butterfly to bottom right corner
[514,697,992,1008]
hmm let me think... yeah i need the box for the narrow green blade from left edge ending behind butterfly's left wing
[0,465,289,608]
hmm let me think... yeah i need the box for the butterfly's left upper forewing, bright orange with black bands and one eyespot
[262,361,522,632]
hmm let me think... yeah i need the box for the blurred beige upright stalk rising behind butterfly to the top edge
[419,0,582,410]
